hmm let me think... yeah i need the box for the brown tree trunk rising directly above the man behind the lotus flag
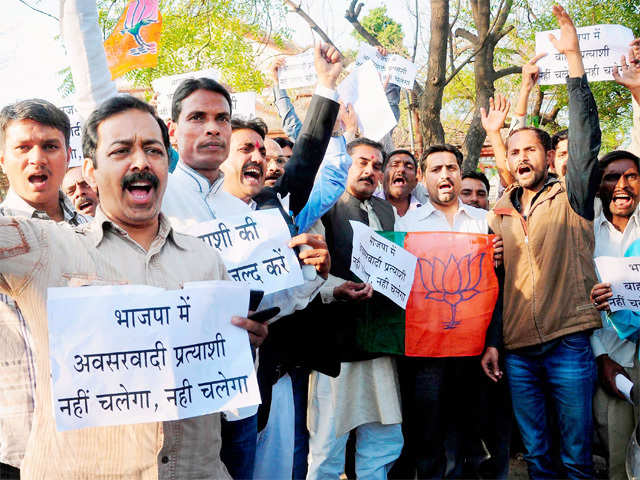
[420,0,449,148]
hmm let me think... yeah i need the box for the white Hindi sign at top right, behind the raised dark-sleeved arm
[536,25,633,85]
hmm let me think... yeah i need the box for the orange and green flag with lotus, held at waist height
[357,232,499,357]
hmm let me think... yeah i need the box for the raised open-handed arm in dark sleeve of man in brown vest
[550,5,601,220]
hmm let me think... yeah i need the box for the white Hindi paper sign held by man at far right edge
[595,257,640,312]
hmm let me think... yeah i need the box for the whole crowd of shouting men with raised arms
[0,0,640,480]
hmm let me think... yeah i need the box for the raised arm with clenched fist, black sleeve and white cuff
[273,45,342,215]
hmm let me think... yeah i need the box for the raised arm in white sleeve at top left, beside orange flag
[60,0,118,120]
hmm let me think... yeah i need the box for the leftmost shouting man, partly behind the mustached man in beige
[0,99,87,478]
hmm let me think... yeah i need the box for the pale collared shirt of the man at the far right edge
[591,207,640,367]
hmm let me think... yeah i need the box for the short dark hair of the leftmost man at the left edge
[0,98,71,148]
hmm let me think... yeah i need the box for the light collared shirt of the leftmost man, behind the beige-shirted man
[0,188,88,467]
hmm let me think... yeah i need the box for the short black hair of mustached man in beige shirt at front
[82,95,171,168]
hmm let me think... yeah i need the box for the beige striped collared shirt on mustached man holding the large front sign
[0,207,229,480]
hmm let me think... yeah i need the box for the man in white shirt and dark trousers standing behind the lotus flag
[394,144,500,478]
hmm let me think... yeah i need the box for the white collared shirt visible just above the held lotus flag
[396,199,489,233]
